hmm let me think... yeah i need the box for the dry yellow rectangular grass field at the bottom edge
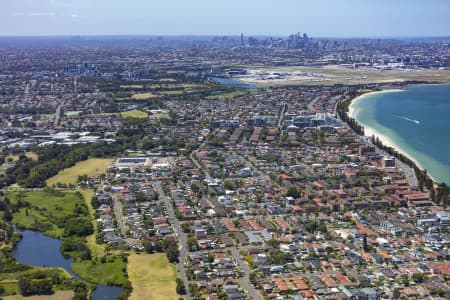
[128,253,178,300]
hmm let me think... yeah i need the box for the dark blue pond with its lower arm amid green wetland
[13,230,123,300]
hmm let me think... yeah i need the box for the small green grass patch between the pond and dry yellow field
[72,256,127,285]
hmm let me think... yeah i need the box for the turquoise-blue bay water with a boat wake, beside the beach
[352,84,450,184]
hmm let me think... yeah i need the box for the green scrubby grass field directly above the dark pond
[7,190,84,237]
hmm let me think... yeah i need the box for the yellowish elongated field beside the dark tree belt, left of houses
[46,158,113,186]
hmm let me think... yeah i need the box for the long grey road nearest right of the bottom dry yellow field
[153,180,190,299]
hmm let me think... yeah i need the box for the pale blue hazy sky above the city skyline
[0,0,450,37]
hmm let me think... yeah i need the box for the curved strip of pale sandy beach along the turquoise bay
[348,89,439,183]
